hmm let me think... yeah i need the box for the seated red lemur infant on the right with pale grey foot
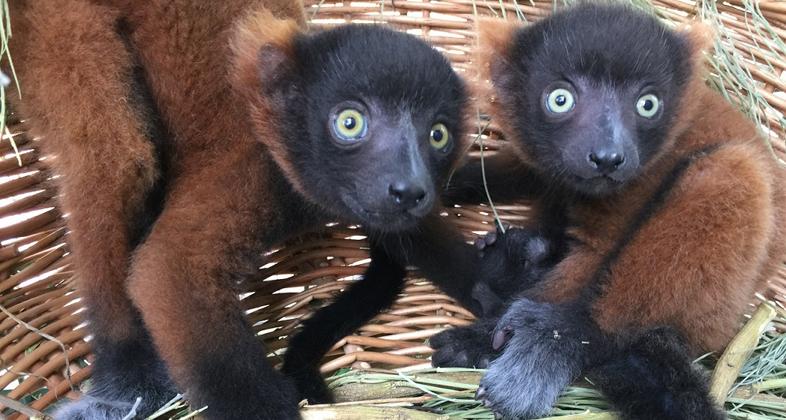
[431,3,786,419]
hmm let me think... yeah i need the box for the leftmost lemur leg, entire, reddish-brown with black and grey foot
[10,0,175,419]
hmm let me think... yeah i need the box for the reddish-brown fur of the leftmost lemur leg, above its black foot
[10,0,158,339]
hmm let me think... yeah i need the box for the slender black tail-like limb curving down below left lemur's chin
[283,245,406,403]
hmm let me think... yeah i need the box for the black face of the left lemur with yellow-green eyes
[285,25,466,231]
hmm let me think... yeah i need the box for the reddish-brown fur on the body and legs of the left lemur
[11,0,312,412]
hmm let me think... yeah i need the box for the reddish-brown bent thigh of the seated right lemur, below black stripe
[593,145,775,351]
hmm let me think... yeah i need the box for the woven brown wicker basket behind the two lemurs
[0,0,786,419]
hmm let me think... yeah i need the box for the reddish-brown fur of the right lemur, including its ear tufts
[476,21,786,351]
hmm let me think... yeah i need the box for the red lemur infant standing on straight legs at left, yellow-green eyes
[10,0,484,420]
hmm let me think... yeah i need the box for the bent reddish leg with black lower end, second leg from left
[129,148,301,420]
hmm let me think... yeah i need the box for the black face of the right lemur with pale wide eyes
[498,5,689,196]
